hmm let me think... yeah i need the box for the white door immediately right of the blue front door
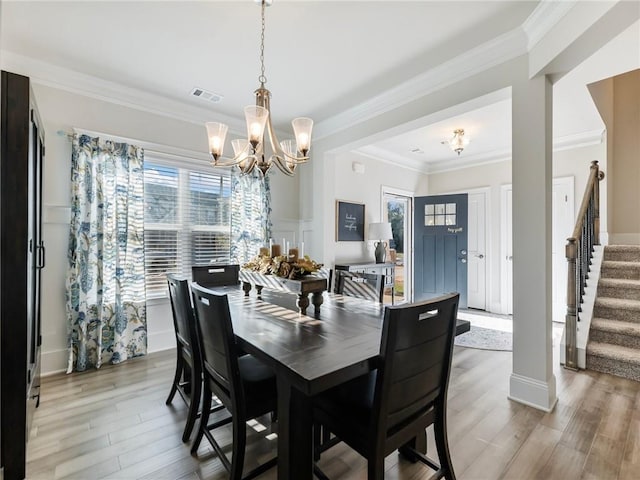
[467,192,487,310]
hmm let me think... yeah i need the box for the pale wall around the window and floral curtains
[34,84,306,374]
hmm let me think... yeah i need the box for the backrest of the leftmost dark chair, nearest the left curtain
[167,273,200,365]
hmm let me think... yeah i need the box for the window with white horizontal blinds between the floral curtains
[144,161,231,298]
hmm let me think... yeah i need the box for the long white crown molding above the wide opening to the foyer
[314,27,527,139]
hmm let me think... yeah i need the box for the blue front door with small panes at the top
[413,193,467,308]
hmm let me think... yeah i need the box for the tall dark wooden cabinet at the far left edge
[0,72,44,480]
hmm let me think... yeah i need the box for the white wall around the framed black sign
[325,153,428,263]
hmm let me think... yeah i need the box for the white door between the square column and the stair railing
[551,177,575,322]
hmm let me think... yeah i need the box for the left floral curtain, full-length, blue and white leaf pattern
[66,135,147,372]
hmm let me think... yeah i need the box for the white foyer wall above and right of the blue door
[428,143,606,313]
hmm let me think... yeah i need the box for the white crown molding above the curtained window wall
[0,50,246,135]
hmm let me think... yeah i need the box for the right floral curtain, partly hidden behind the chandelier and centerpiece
[231,168,271,265]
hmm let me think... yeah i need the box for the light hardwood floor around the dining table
[27,347,640,480]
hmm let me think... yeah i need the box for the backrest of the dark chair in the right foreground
[373,293,460,438]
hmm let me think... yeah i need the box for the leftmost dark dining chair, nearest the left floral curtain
[166,274,220,442]
